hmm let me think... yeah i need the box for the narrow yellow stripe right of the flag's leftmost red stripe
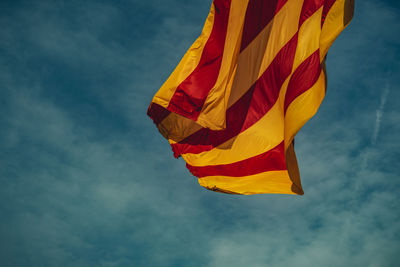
[197,0,249,130]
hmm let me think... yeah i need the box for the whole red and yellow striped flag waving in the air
[147,0,354,195]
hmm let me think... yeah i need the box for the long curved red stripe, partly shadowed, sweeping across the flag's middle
[171,34,297,157]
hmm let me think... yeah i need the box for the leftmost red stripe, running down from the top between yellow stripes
[168,0,230,120]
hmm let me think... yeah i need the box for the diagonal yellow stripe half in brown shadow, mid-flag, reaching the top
[228,0,303,107]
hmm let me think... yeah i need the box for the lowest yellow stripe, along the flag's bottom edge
[198,171,296,195]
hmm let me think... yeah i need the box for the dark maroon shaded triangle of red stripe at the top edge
[240,0,288,51]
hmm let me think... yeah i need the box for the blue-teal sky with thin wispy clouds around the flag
[0,0,400,267]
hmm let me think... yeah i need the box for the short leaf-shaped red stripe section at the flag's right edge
[285,50,321,112]
